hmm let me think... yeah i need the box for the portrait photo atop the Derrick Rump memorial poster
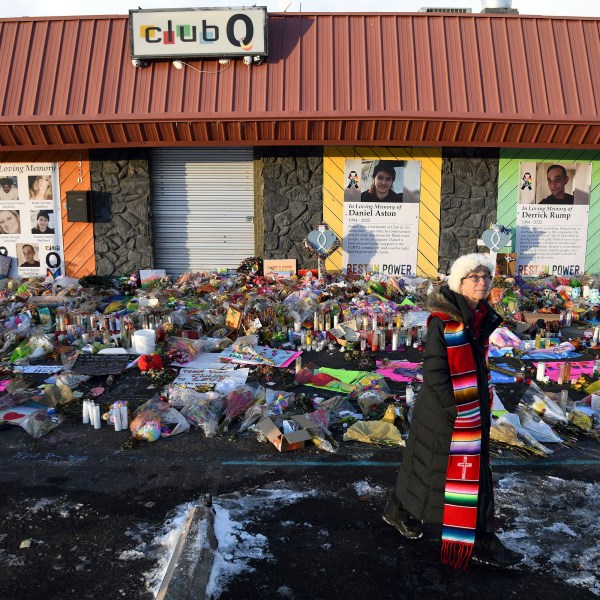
[518,161,592,206]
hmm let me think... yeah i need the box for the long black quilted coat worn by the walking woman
[386,286,502,532]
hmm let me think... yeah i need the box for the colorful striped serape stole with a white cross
[438,314,487,569]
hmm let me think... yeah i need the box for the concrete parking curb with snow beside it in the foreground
[156,506,217,600]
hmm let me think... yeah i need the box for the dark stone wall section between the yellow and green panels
[438,148,499,273]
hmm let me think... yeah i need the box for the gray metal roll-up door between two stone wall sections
[152,148,255,274]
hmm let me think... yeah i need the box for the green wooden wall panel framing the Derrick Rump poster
[496,149,600,274]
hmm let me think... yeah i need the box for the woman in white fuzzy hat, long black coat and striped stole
[383,254,523,568]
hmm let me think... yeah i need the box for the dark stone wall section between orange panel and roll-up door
[90,149,154,275]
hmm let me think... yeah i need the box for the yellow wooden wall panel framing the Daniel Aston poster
[323,146,442,278]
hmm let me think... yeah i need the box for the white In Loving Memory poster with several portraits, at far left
[0,165,62,275]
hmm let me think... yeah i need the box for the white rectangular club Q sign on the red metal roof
[129,6,267,59]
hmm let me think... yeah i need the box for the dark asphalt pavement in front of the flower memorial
[0,344,600,600]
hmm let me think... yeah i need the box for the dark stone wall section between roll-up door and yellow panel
[257,147,323,269]
